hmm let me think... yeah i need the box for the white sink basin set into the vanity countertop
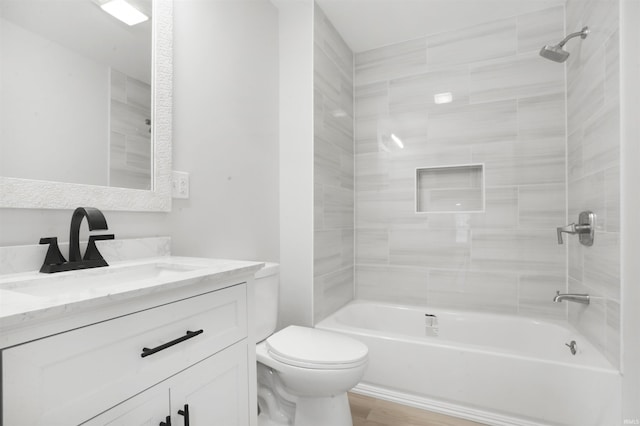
[0,262,205,298]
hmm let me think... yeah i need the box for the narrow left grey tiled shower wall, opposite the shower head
[313,5,354,322]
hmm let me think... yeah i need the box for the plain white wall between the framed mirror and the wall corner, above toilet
[170,0,279,261]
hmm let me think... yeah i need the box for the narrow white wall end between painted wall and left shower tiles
[273,0,313,326]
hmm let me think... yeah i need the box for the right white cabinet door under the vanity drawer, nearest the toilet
[171,340,249,426]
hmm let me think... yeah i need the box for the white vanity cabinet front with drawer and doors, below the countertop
[2,272,255,426]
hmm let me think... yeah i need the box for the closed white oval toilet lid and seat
[266,325,369,369]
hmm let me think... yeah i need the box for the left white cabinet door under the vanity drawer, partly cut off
[82,383,173,426]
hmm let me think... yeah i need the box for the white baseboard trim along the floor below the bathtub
[351,383,549,426]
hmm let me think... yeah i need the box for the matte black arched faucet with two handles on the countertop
[40,207,114,274]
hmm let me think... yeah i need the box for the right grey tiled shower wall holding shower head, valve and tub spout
[567,0,621,366]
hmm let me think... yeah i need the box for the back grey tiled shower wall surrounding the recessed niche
[355,7,567,318]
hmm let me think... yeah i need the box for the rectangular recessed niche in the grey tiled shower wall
[416,164,484,213]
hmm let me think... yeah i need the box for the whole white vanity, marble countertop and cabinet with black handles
[0,256,262,426]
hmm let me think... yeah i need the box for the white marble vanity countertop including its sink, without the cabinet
[0,256,264,330]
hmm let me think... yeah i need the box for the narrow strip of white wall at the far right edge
[620,0,640,424]
